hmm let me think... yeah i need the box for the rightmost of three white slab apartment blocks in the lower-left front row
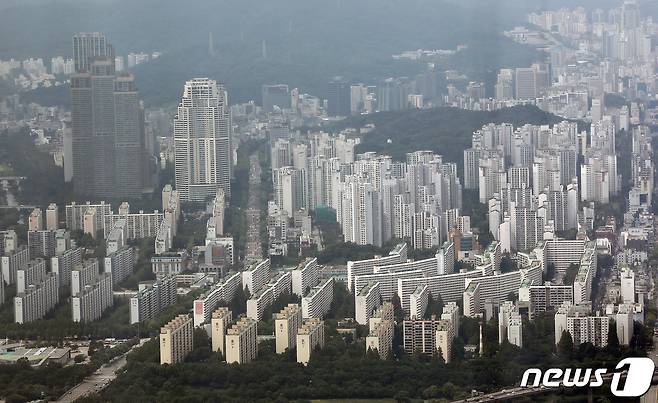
[130,275,178,325]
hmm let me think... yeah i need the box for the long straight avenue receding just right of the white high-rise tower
[244,153,263,263]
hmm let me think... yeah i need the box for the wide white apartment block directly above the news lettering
[555,302,610,347]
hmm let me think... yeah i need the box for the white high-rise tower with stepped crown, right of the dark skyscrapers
[174,78,232,201]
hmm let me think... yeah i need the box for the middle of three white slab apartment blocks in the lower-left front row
[71,273,114,323]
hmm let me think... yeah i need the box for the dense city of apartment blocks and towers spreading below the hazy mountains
[0,0,658,402]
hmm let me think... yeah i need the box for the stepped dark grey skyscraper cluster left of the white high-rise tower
[69,33,149,198]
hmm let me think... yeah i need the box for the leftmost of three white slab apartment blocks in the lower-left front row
[14,273,59,324]
